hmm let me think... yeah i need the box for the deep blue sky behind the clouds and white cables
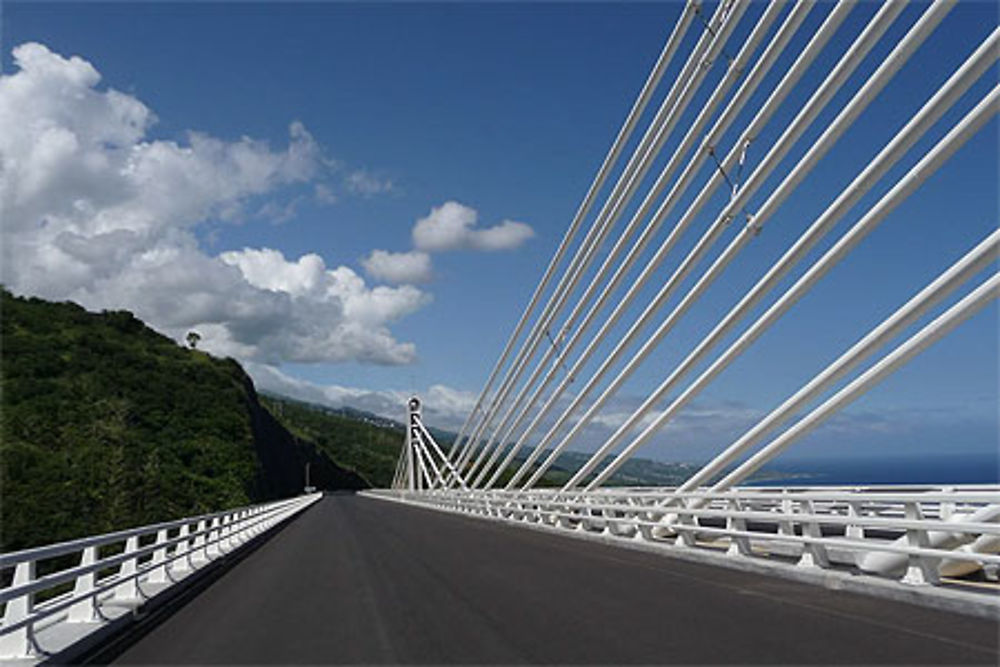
[2,2,998,470]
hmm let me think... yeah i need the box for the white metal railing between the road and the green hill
[0,493,322,663]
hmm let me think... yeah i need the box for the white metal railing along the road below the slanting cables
[366,485,1000,592]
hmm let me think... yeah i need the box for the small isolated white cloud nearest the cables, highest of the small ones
[413,201,535,252]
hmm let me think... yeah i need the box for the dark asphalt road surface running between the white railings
[117,496,998,665]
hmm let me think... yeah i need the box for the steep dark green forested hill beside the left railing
[0,290,368,550]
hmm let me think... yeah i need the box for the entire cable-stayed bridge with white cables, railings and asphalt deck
[0,0,1000,664]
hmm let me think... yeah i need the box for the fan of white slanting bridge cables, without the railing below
[394,0,1000,552]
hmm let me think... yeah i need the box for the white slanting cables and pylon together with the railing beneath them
[384,0,1000,604]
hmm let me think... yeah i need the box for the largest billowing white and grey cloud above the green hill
[0,43,430,364]
